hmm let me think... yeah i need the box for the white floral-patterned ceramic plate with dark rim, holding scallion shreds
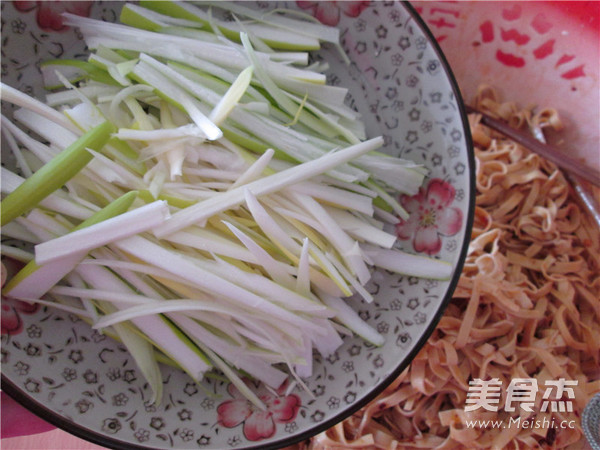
[2,2,474,449]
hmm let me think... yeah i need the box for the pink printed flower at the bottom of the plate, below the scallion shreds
[217,382,301,441]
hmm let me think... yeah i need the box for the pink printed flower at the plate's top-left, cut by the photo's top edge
[13,0,94,31]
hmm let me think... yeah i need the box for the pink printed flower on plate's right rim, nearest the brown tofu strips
[396,178,463,255]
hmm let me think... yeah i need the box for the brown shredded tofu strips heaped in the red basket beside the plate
[296,87,600,449]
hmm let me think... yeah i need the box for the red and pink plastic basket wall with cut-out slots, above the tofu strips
[413,1,600,165]
